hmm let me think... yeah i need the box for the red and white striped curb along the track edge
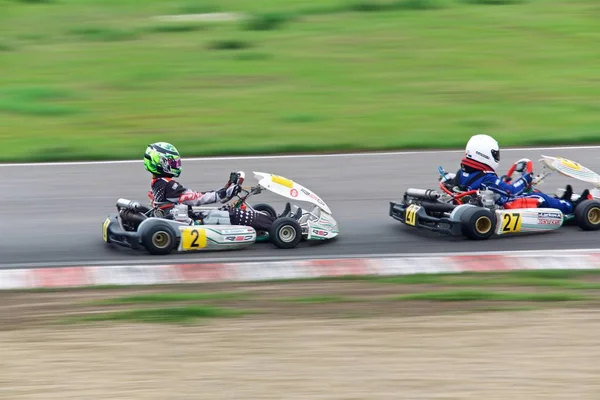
[0,250,600,290]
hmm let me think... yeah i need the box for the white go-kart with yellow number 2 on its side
[102,171,339,255]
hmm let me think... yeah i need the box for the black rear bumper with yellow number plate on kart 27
[389,201,462,236]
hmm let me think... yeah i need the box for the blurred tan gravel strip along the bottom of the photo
[0,310,600,400]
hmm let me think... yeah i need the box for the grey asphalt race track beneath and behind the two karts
[0,147,600,268]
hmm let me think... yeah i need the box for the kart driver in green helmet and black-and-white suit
[144,142,302,231]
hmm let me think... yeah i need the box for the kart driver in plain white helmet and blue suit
[454,135,590,214]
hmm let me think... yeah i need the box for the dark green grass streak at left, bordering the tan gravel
[68,306,247,323]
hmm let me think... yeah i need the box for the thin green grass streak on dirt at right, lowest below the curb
[393,290,588,302]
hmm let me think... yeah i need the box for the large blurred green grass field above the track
[0,0,600,161]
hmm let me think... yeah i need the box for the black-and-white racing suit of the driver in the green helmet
[151,177,275,231]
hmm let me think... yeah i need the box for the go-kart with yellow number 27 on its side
[389,156,600,240]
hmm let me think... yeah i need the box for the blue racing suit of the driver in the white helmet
[455,159,573,214]
